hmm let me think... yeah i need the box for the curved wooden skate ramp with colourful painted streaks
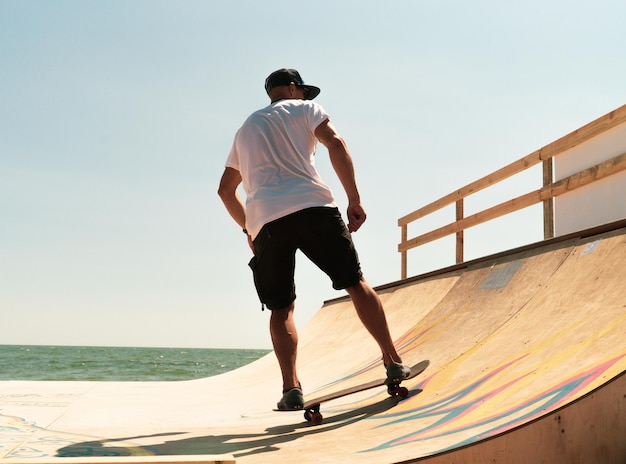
[0,224,626,464]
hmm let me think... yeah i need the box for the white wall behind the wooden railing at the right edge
[554,123,626,236]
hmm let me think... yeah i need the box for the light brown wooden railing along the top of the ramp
[398,105,626,279]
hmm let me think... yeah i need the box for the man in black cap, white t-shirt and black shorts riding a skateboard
[218,68,410,409]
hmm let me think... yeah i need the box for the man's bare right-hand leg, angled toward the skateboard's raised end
[346,279,402,365]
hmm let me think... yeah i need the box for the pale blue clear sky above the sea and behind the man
[0,0,626,348]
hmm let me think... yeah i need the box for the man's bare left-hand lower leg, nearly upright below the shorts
[270,303,300,390]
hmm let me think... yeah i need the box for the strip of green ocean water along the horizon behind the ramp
[0,345,270,381]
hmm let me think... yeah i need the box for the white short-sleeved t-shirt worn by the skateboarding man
[226,99,336,238]
